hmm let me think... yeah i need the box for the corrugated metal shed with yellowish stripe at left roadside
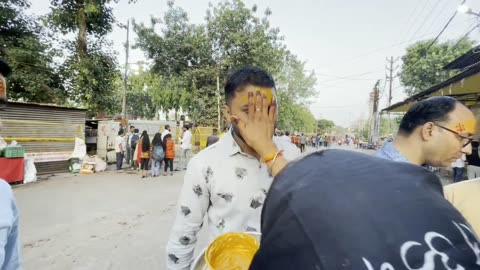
[0,102,86,173]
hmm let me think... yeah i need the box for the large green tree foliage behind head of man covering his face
[134,0,316,130]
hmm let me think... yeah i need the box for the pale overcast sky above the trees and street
[30,0,480,127]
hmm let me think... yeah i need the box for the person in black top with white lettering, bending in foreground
[250,150,480,270]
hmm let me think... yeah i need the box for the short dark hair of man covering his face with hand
[225,67,275,104]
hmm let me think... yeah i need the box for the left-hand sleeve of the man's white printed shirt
[167,156,210,270]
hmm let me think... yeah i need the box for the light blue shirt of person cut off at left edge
[0,179,21,270]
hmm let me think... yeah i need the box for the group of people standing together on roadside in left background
[115,125,192,178]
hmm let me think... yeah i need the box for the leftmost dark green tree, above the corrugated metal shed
[0,0,66,104]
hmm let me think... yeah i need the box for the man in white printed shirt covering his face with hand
[167,68,300,269]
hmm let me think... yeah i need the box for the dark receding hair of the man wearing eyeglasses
[398,97,458,135]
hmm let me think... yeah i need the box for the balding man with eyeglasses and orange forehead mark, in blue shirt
[375,97,477,167]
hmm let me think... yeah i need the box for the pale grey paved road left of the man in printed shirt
[14,147,372,270]
